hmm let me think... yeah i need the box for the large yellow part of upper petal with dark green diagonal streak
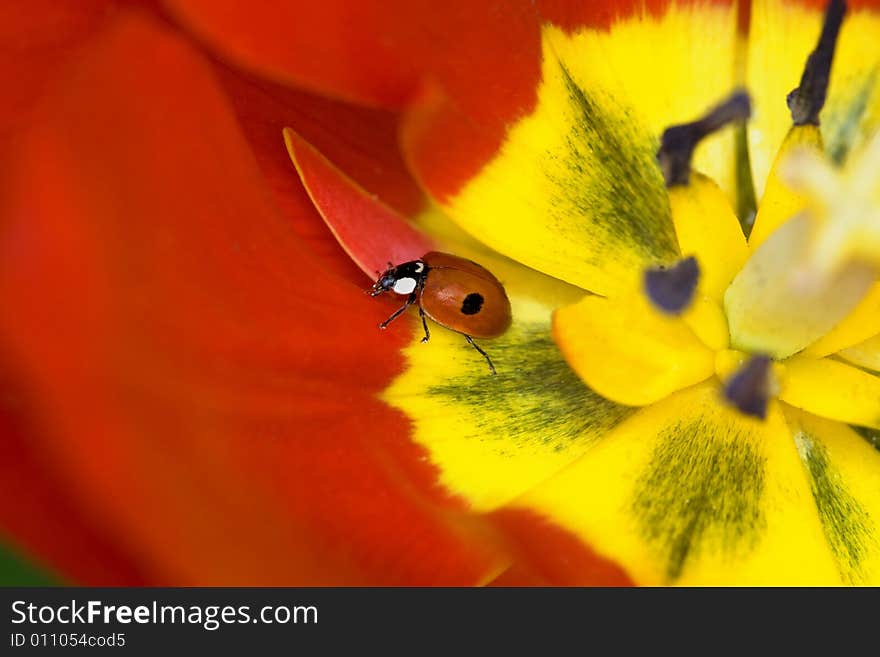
[436,3,736,295]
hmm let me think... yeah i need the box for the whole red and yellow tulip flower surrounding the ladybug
[0,0,880,585]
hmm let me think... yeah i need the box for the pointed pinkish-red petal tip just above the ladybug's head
[284,128,436,279]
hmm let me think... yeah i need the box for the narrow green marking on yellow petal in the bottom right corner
[795,432,877,584]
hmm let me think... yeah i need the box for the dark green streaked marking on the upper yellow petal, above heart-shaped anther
[548,62,679,261]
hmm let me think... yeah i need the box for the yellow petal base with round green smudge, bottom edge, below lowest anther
[515,384,840,585]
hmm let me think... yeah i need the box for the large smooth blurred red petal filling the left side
[0,10,506,585]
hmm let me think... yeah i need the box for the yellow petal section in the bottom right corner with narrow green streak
[785,407,880,586]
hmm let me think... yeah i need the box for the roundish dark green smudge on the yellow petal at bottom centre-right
[632,421,766,581]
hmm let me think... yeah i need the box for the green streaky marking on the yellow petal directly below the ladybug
[427,326,635,453]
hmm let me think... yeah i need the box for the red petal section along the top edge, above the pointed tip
[166,0,540,119]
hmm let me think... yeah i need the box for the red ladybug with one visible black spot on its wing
[370,251,511,374]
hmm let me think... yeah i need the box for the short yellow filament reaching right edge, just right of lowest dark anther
[779,356,880,428]
